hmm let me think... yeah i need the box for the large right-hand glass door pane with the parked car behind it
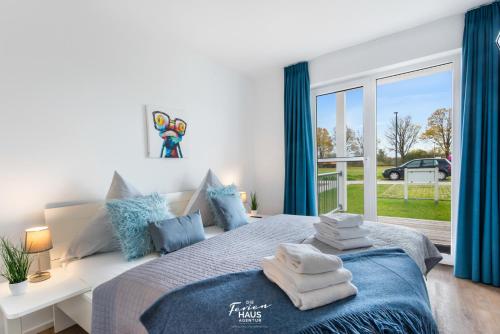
[377,64,455,254]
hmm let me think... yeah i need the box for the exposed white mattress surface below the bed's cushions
[64,226,224,299]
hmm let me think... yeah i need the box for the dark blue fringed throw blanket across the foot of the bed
[141,249,438,334]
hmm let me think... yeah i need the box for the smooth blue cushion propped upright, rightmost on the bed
[207,185,248,231]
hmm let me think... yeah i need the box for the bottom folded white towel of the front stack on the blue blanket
[262,263,358,311]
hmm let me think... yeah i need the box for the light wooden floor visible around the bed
[42,265,500,334]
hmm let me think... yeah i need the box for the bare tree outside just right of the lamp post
[385,116,421,160]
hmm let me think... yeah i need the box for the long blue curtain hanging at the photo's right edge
[455,2,500,286]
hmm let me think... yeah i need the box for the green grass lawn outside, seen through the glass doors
[319,184,451,221]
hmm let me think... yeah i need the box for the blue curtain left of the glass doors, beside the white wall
[284,62,317,216]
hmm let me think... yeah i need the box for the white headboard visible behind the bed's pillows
[45,191,194,261]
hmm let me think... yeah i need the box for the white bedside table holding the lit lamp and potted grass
[0,268,90,334]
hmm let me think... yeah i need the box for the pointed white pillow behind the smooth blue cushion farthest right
[183,169,222,226]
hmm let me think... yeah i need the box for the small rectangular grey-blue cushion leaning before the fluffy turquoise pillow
[148,211,205,254]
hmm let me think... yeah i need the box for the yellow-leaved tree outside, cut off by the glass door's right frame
[420,108,452,157]
